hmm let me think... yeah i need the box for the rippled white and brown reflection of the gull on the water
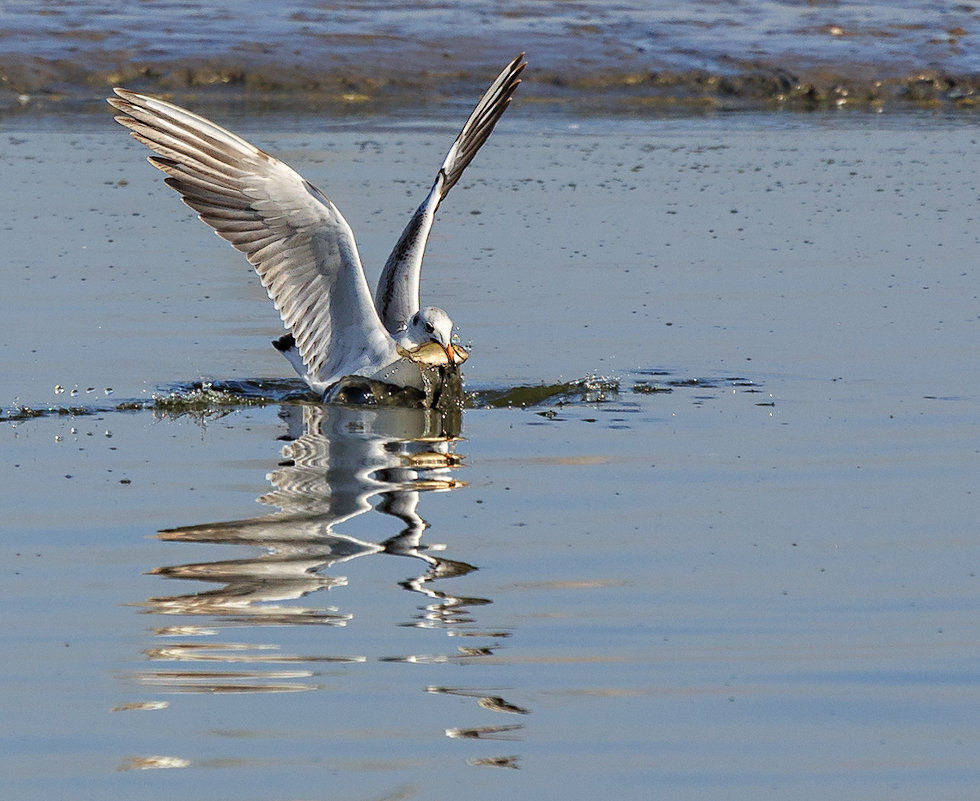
[118,405,529,769]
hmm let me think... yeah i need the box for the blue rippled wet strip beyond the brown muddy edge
[0,0,980,90]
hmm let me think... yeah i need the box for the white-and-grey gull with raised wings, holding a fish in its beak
[108,53,527,400]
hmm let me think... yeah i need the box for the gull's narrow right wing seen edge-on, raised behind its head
[374,53,527,333]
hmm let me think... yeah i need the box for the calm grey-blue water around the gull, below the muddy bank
[0,114,980,799]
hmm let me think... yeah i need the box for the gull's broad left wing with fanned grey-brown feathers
[109,89,397,384]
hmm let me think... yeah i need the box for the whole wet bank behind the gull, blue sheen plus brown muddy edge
[0,0,980,114]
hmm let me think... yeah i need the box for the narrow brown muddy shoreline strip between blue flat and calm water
[0,53,980,115]
